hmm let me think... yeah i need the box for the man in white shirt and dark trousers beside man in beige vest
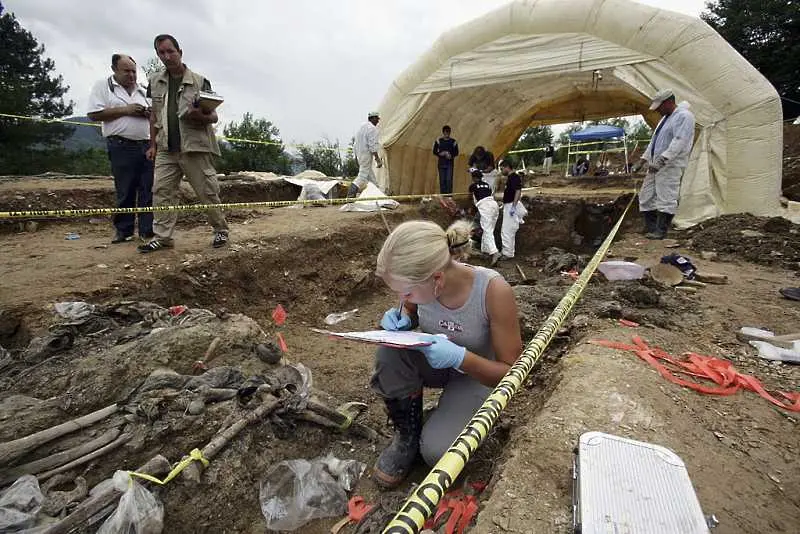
[87,54,153,243]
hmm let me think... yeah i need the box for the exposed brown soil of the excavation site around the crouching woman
[0,175,800,534]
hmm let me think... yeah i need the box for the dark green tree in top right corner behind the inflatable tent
[700,0,800,117]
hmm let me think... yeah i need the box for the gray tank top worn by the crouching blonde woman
[417,265,500,360]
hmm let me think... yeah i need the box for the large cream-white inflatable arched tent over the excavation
[378,0,783,226]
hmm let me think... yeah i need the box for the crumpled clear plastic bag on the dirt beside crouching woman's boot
[259,454,366,531]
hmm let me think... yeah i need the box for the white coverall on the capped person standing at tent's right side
[639,102,694,215]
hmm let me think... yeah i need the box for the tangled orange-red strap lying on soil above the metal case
[589,336,800,412]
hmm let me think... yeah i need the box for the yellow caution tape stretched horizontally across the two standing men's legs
[0,193,470,220]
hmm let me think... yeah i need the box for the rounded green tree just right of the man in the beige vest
[220,113,289,174]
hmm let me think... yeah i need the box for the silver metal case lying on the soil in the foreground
[573,432,713,534]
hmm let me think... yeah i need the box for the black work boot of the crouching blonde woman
[372,391,422,489]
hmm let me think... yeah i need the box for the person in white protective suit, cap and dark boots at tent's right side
[633,89,695,239]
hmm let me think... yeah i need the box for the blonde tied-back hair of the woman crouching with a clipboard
[375,221,472,284]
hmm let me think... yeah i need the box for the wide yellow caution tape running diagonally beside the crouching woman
[383,191,636,534]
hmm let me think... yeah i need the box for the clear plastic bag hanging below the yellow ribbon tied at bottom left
[97,471,164,534]
